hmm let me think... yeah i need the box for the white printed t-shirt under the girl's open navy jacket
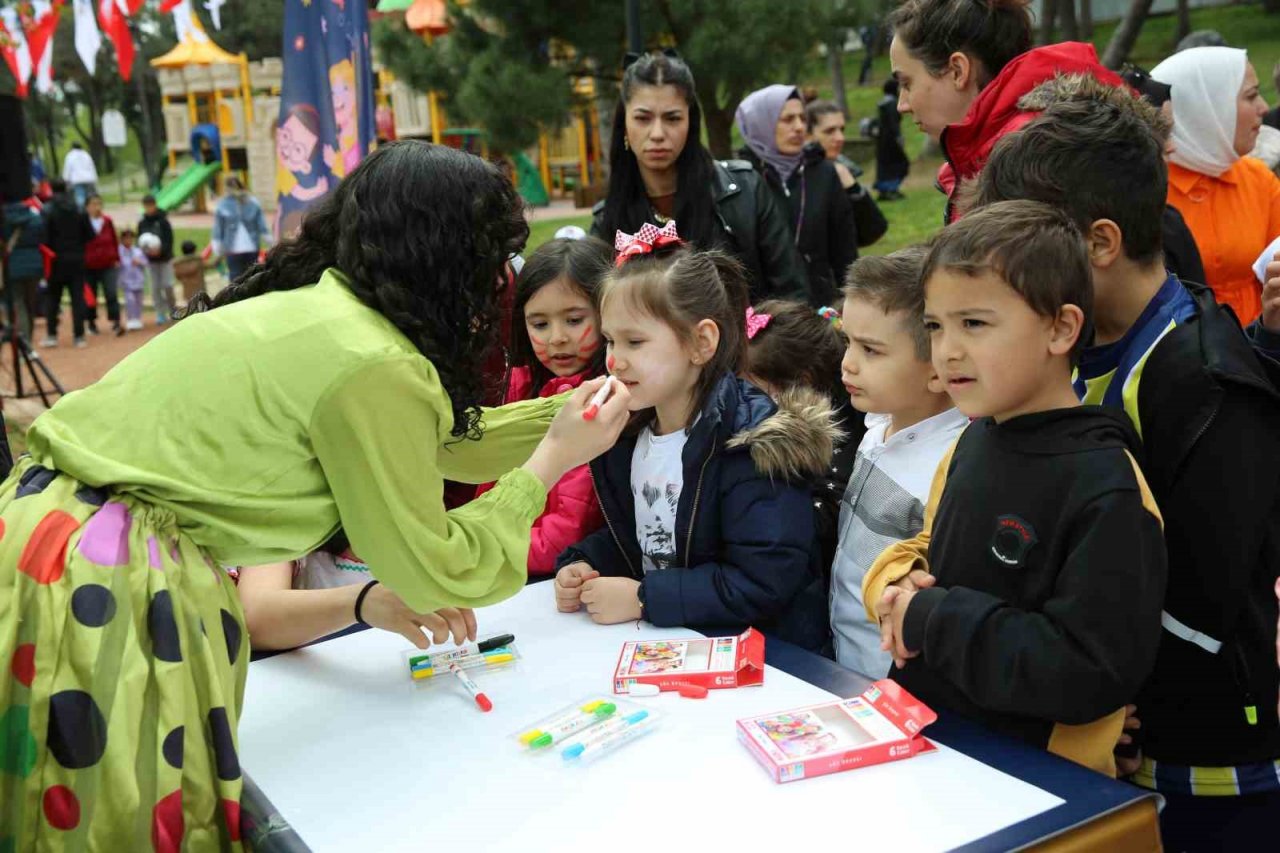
[631,427,689,574]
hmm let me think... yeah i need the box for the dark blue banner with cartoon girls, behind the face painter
[275,0,375,237]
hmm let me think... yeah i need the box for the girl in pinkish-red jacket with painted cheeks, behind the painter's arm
[477,238,613,579]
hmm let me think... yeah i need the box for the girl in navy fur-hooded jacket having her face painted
[556,224,837,648]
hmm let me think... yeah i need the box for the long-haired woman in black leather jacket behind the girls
[591,54,809,301]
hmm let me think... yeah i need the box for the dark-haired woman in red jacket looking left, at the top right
[888,0,1121,223]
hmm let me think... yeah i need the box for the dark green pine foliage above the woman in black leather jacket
[374,0,849,156]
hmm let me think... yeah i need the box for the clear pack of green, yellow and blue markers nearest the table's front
[513,695,659,766]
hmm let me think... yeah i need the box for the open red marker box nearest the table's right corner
[737,679,938,783]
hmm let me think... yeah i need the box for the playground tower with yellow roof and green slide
[151,15,284,211]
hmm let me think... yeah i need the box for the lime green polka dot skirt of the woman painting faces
[0,460,247,853]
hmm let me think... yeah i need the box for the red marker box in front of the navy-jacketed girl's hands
[613,628,764,693]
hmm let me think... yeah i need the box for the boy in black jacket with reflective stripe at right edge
[977,77,1280,850]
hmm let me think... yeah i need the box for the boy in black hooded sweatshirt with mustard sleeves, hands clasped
[863,201,1166,776]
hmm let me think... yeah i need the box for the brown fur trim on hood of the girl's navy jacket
[726,388,844,483]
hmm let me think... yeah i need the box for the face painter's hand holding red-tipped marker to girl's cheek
[524,377,631,489]
